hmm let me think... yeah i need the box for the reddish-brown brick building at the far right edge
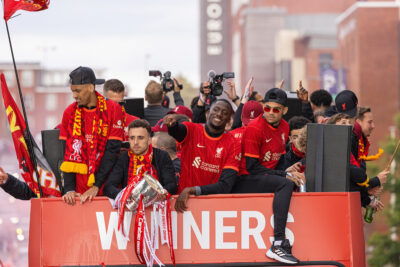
[337,2,400,147]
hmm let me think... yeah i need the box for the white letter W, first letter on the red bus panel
[96,212,132,250]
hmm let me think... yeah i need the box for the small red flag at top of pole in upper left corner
[4,0,50,21]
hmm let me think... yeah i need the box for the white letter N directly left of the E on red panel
[183,211,210,249]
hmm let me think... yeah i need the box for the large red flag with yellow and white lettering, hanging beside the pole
[0,73,61,197]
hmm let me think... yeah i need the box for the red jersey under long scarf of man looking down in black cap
[59,100,124,195]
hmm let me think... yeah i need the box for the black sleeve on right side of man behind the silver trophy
[158,151,178,195]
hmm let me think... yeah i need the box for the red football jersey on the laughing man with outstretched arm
[178,122,240,194]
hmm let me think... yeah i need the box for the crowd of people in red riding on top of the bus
[0,67,388,264]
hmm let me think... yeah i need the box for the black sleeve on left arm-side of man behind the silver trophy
[103,154,126,199]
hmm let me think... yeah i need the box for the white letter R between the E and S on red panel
[242,211,266,249]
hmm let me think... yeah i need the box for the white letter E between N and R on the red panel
[215,211,237,249]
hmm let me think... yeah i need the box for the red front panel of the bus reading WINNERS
[29,192,365,267]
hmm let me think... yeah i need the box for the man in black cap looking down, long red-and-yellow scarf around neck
[59,67,124,205]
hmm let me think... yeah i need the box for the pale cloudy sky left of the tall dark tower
[0,0,200,97]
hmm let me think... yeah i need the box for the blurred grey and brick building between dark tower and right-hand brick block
[232,0,355,93]
